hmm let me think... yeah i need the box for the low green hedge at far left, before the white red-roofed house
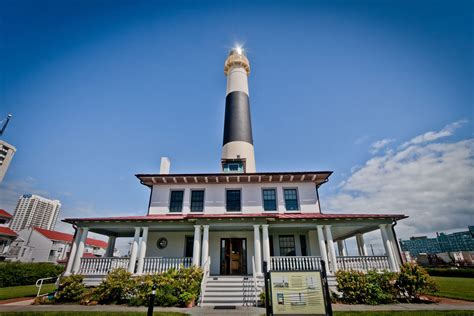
[0,262,64,287]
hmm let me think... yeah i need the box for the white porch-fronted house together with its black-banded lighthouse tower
[64,48,406,302]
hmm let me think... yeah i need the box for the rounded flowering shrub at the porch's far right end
[396,263,438,301]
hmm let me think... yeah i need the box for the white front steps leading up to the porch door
[201,275,264,306]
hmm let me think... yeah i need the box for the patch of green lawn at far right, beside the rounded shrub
[432,276,474,301]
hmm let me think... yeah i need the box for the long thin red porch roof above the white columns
[63,213,408,224]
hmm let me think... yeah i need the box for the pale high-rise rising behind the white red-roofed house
[10,194,61,232]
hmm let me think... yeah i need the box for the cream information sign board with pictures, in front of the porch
[268,271,328,315]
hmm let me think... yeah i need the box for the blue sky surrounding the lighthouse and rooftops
[0,0,474,244]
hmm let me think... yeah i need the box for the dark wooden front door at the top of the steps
[221,238,247,275]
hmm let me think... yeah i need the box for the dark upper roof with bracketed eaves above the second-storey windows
[135,171,332,187]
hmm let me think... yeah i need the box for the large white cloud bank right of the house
[327,121,474,242]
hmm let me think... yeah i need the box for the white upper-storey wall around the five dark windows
[149,182,319,214]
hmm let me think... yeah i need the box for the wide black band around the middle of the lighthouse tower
[223,91,253,145]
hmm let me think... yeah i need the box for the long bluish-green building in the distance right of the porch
[400,226,474,257]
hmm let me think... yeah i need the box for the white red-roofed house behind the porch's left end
[9,227,107,263]
